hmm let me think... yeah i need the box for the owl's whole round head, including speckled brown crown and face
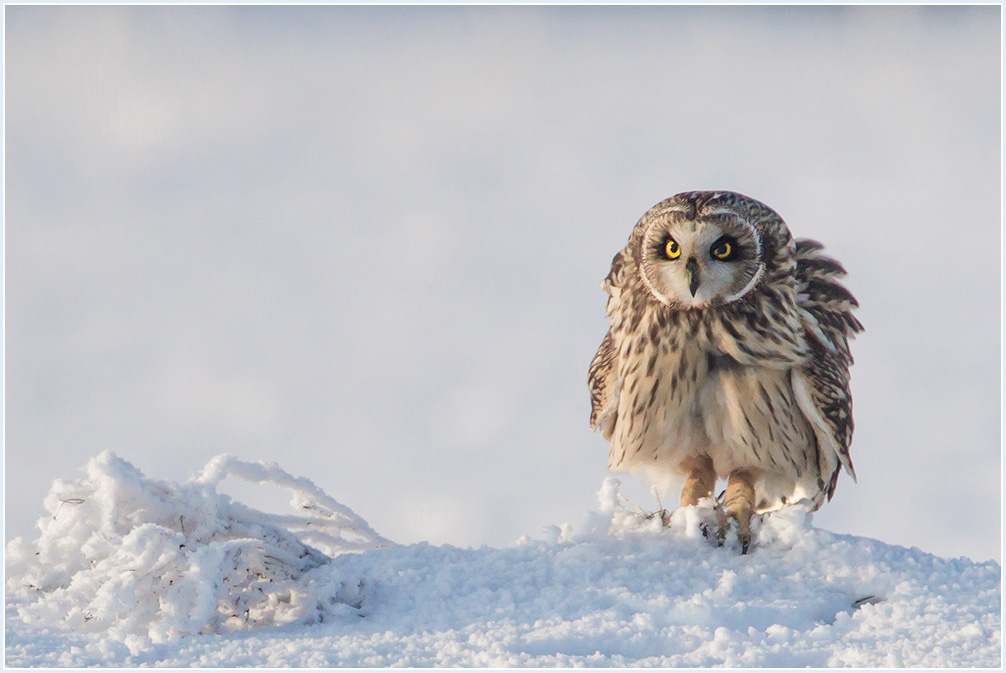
[630,192,789,308]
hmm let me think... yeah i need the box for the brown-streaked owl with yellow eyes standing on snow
[589,191,863,553]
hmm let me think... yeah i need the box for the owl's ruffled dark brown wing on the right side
[793,239,863,500]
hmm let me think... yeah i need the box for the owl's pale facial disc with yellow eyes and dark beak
[642,212,763,308]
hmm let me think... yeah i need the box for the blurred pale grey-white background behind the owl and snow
[5,6,1001,560]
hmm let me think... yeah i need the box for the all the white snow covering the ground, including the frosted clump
[5,452,1002,668]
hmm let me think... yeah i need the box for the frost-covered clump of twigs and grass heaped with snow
[6,452,388,649]
